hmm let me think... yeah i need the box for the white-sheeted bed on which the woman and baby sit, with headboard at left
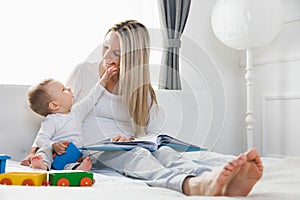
[0,85,300,200]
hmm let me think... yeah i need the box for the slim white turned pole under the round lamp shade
[245,48,254,149]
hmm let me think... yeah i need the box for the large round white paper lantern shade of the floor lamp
[211,0,282,50]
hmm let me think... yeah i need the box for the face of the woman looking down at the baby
[102,31,120,68]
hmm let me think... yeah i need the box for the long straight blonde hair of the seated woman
[107,20,157,137]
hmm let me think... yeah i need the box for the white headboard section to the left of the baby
[0,85,43,160]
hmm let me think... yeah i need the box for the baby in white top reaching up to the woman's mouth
[28,67,118,171]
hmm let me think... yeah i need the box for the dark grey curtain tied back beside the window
[158,0,191,90]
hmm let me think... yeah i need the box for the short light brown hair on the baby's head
[28,78,54,116]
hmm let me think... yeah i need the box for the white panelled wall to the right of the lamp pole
[241,0,300,157]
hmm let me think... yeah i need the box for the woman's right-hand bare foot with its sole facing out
[223,149,263,196]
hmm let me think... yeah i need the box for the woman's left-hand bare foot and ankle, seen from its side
[183,154,247,196]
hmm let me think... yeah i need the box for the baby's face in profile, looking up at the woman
[47,81,74,113]
